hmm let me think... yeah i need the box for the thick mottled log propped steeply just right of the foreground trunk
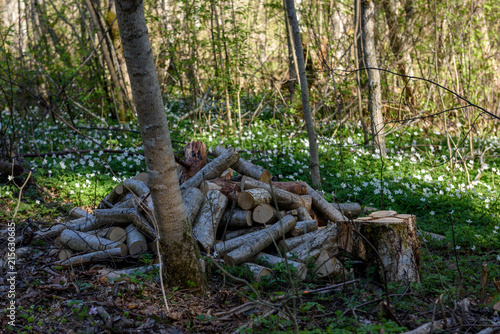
[193,189,227,252]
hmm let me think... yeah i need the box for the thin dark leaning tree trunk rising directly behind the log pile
[285,0,321,189]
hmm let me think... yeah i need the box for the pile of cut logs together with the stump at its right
[35,142,420,283]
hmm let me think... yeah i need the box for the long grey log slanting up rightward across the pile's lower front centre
[224,215,297,266]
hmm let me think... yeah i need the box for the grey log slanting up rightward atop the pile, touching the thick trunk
[181,148,240,192]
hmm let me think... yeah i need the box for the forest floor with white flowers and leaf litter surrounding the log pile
[0,111,500,333]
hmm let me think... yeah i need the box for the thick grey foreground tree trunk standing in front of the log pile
[116,0,204,286]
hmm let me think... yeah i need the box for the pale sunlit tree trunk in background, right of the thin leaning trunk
[361,0,387,157]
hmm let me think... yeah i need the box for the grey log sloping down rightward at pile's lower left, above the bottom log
[61,229,127,256]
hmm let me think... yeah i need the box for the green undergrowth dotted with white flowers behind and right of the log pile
[0,103,500,333]
